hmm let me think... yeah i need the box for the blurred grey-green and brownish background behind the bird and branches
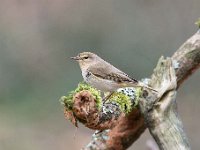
[0,0,200,150]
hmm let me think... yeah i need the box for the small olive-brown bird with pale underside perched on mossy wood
[71,52,157,99]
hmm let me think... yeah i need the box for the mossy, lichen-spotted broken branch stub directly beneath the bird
[60,82,141,130]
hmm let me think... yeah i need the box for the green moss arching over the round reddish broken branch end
[60,82,102,110]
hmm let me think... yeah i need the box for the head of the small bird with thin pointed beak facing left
[71,52,100,69]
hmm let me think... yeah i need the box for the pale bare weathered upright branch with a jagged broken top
[140,57,190,150]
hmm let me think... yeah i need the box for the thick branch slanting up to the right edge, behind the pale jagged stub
[172,30,200,88]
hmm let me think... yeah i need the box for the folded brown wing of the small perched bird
[88,66,138,83]
